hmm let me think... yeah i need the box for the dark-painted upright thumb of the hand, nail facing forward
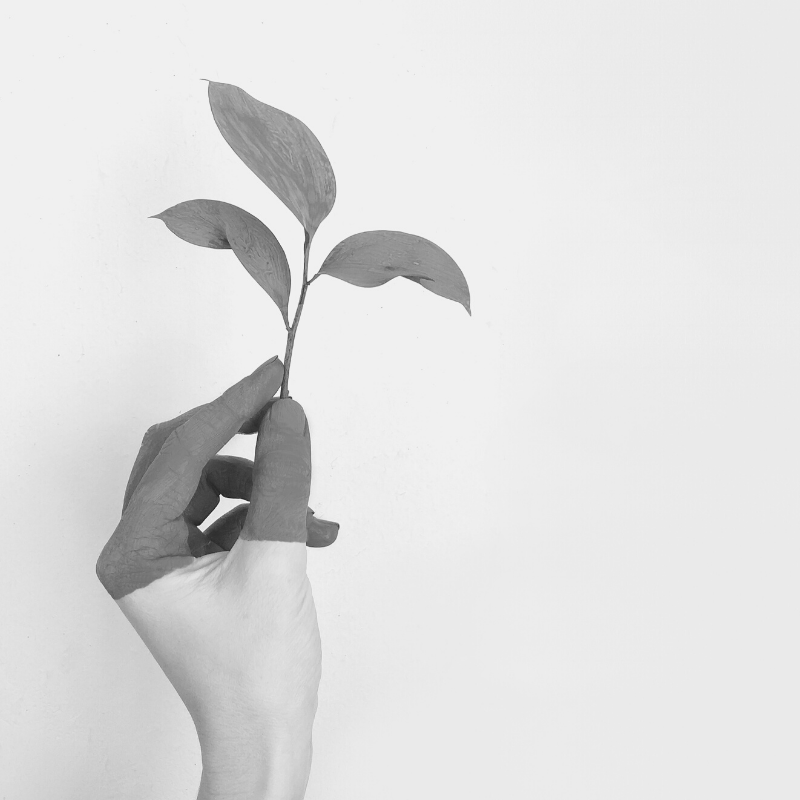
[239,398,311,543]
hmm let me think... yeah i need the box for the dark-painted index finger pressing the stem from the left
[131,356,283,519]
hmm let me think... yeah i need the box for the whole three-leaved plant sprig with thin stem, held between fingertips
[154,81,472,398]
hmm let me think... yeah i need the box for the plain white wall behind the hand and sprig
[0,0,800,800]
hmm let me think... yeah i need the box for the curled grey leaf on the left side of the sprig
[152,200,292,325]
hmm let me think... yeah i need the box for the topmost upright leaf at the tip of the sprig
[208,81,336,238]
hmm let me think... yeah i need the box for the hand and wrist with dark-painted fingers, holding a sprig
[97,358,338,800]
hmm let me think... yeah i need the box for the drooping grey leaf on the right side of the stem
[319,231,472,316]
